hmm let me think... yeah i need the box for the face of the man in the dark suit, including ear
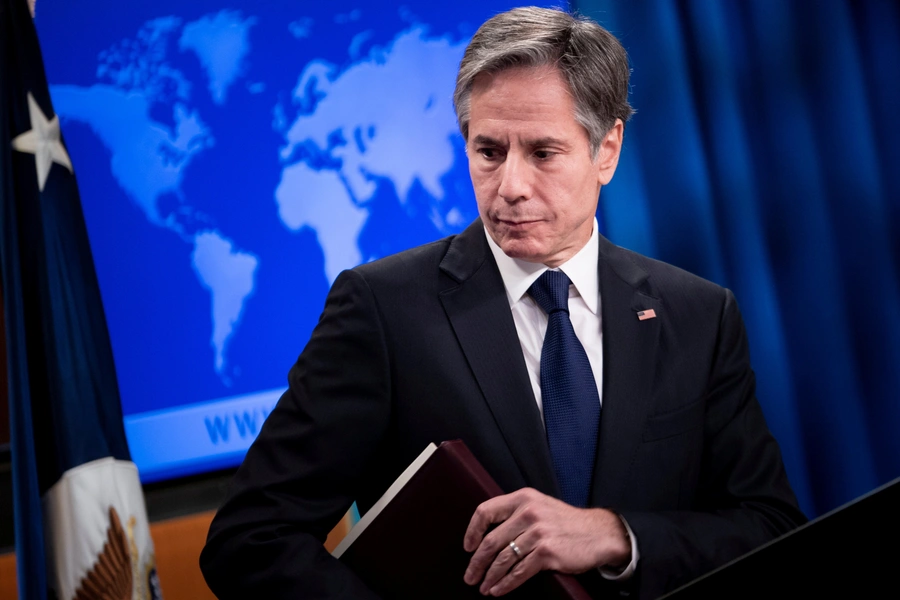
[466,67,623,267]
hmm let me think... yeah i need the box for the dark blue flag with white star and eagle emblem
[0,0,159,600]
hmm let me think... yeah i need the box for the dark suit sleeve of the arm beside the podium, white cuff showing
[620,290,806,598]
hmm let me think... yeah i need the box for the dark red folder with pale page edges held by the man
[334,440,590,600]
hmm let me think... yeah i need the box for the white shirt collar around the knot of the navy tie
[484,218,600,315]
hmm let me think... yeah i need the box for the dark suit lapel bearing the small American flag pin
[591,237,663,506]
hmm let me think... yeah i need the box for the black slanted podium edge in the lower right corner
[663,478,900,600]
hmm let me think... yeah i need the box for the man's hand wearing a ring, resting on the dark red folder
[463,488,631,596]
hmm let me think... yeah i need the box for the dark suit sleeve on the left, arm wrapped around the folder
[200,271,391,600]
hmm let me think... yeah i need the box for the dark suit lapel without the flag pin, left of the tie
[440,219,559,496]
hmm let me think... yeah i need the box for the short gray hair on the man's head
[453,6,634,158]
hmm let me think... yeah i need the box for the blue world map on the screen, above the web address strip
[36,0,528,428]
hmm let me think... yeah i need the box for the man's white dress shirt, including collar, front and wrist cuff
[484,219,639,580]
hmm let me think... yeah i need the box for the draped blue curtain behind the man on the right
[573,0,900,516]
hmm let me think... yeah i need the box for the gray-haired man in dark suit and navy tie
[201,8,804,598]
